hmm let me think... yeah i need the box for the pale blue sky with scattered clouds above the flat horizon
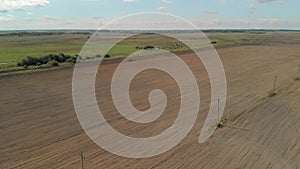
[0,0,300,30]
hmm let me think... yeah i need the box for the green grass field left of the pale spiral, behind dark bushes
[0,34,88,63]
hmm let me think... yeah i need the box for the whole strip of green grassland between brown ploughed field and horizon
[0,31,300,74]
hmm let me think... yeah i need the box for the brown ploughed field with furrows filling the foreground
[0,32,300,169]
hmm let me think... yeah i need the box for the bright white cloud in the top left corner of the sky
[0,0,49,12]
